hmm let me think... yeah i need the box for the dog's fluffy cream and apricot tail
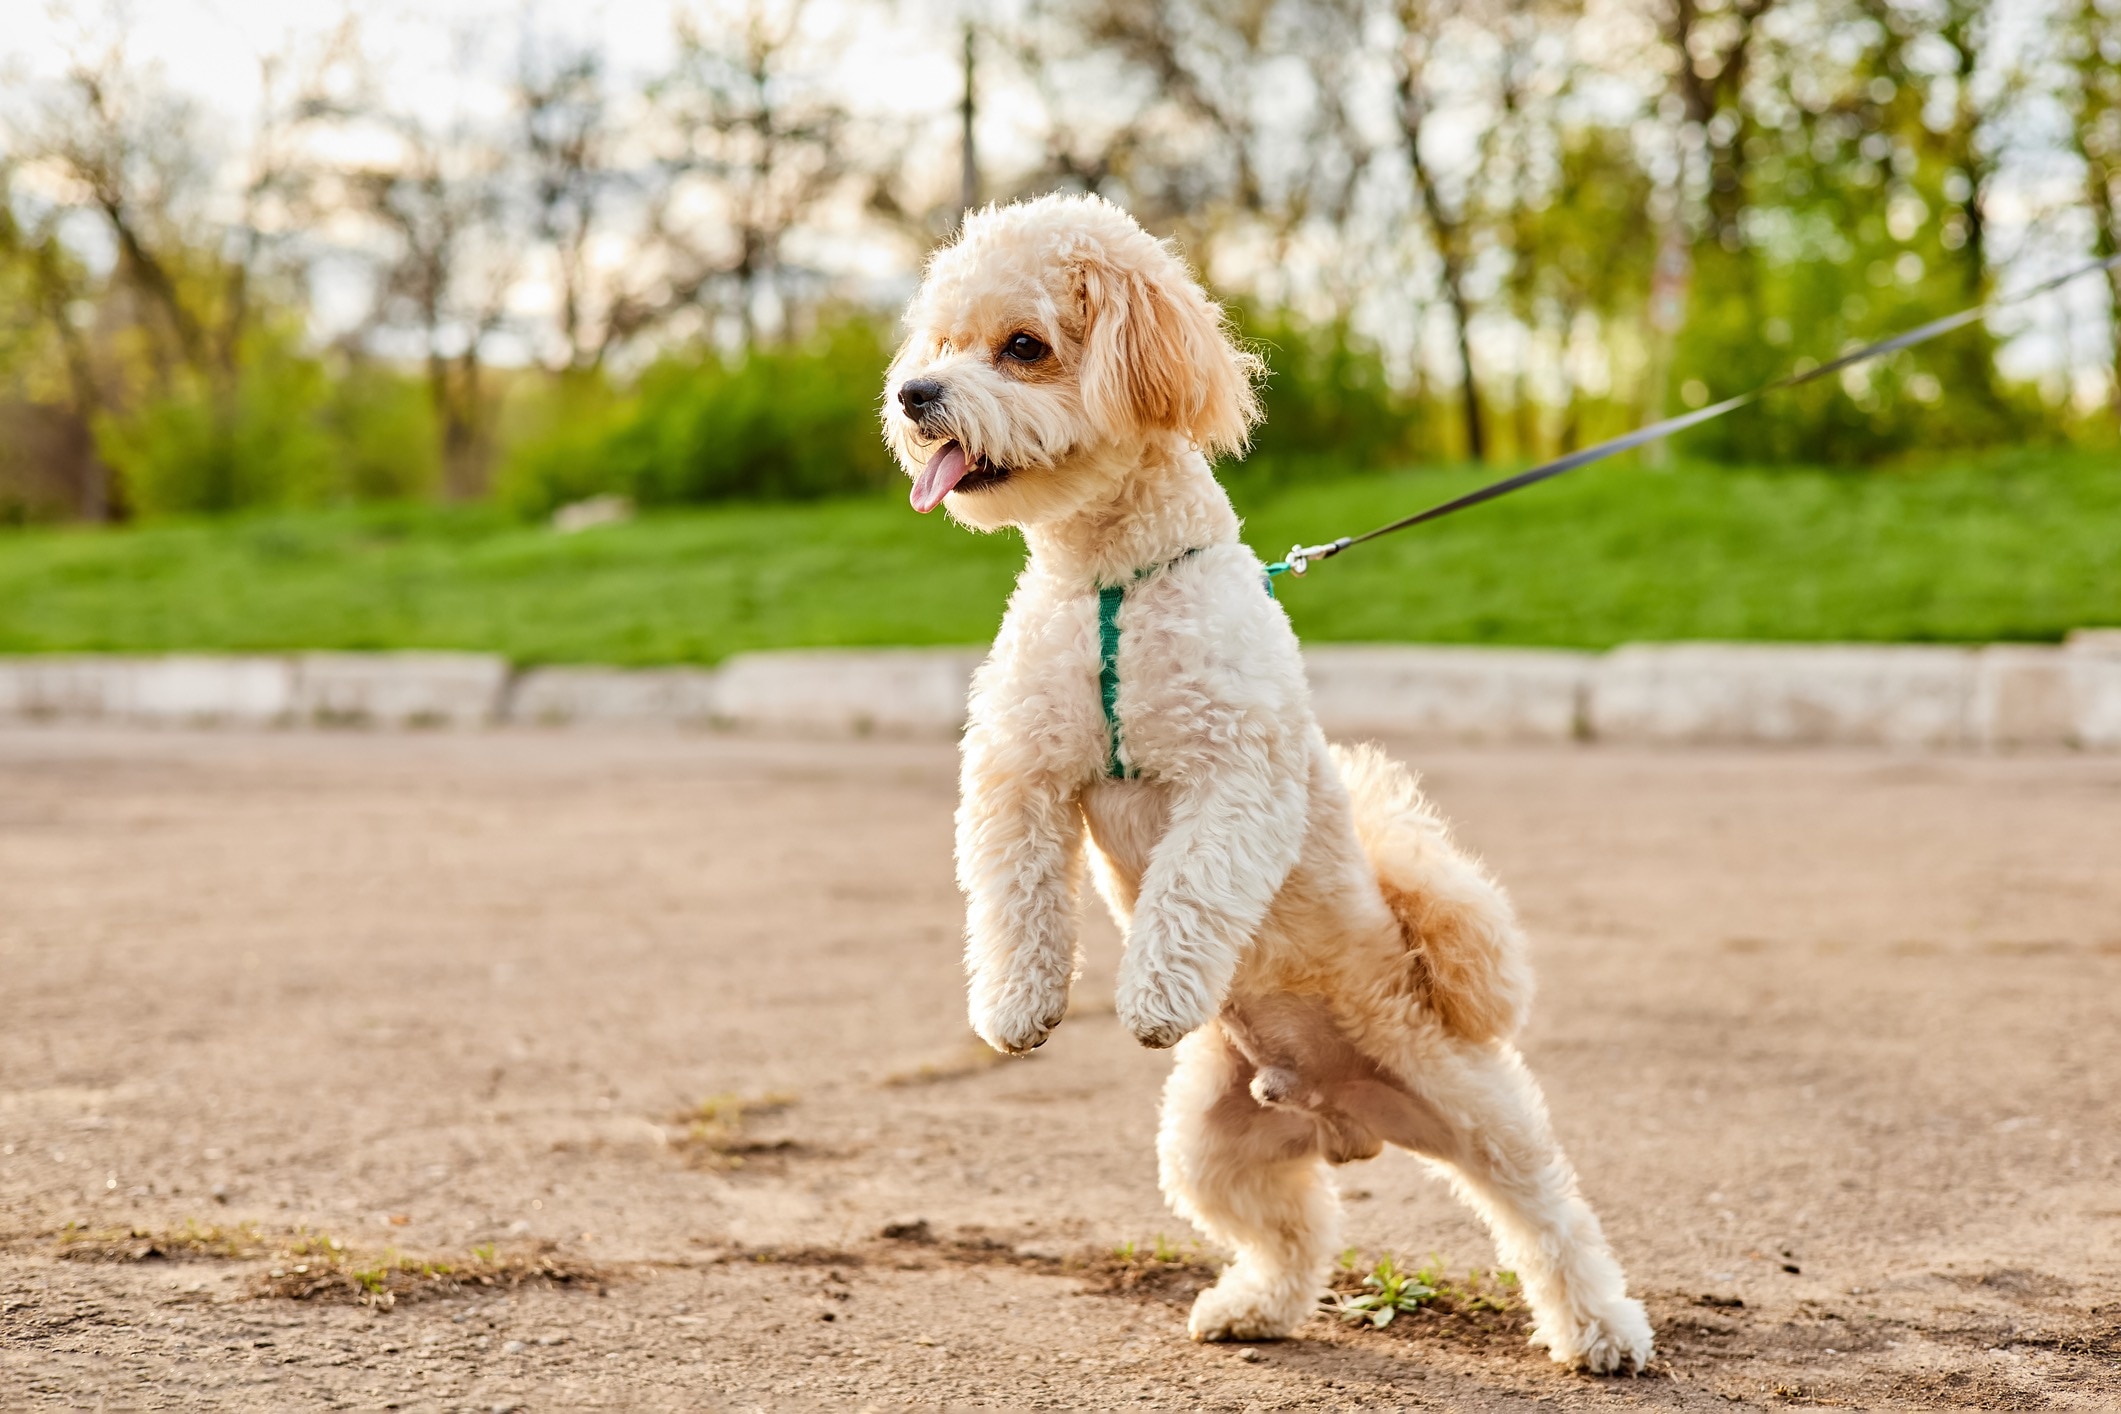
[1332,744,1531,1041]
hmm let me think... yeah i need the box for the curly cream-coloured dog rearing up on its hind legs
[884,197,1650,1372]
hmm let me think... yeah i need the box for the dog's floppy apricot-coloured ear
[1080,246,1260,456]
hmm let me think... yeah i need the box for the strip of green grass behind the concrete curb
[0,452,2121,664]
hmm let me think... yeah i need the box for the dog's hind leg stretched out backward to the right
[1410,1045,1652,1374]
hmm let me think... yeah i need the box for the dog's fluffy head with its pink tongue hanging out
[884,197,1260,530]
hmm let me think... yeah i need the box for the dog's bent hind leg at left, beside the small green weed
[1156,1024,1340,1340]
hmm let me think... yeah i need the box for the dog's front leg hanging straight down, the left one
[957,758,1084,1056]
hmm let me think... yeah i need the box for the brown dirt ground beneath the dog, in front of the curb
[0,727,2121,1410]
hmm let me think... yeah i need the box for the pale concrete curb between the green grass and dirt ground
[0,630,2121,750]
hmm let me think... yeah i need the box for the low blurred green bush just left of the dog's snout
[496,318,897,513]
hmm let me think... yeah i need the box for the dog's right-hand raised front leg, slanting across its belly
[1116,736,1309,1047]
